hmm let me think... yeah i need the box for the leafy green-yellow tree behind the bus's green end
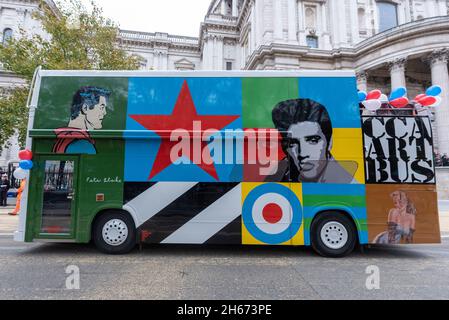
[0,0,139,150]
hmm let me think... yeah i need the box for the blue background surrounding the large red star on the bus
[124,78,243,182]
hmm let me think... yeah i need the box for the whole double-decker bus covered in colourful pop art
[16,71,440,257]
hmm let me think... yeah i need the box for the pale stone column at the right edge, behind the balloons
[427,49,449,155]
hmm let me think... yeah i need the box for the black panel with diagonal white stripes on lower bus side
[124,182,242,244]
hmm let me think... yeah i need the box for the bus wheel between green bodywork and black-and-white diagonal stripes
[93,211,136,254]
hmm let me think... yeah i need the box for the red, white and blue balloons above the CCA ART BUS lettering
[358,86,442,111]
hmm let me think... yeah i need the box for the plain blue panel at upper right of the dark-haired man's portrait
[299,77,361,128]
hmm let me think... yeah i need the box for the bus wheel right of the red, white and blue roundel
[310,212,357,258]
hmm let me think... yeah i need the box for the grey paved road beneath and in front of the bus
[0,209,449,299]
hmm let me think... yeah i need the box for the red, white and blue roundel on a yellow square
[242,183,302,244]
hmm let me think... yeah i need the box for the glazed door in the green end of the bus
[31,155,79,240]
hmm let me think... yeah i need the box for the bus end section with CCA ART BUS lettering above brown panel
[363,115,441,244]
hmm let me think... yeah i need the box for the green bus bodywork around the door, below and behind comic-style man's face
[27,75,128,243]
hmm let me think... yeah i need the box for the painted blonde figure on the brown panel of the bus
[373,191,416,244]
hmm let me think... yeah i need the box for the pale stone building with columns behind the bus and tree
[0,0,449,165]
